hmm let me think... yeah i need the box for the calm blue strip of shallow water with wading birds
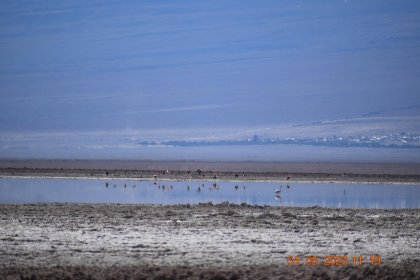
[0,178,420,209]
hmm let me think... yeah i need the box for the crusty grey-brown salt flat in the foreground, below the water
[0,203,420,279]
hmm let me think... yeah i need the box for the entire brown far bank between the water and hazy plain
[0,160,420,184]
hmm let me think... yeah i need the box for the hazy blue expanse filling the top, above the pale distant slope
[0,0,420,160]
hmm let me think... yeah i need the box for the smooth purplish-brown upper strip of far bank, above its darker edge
[0,159,420,175]
